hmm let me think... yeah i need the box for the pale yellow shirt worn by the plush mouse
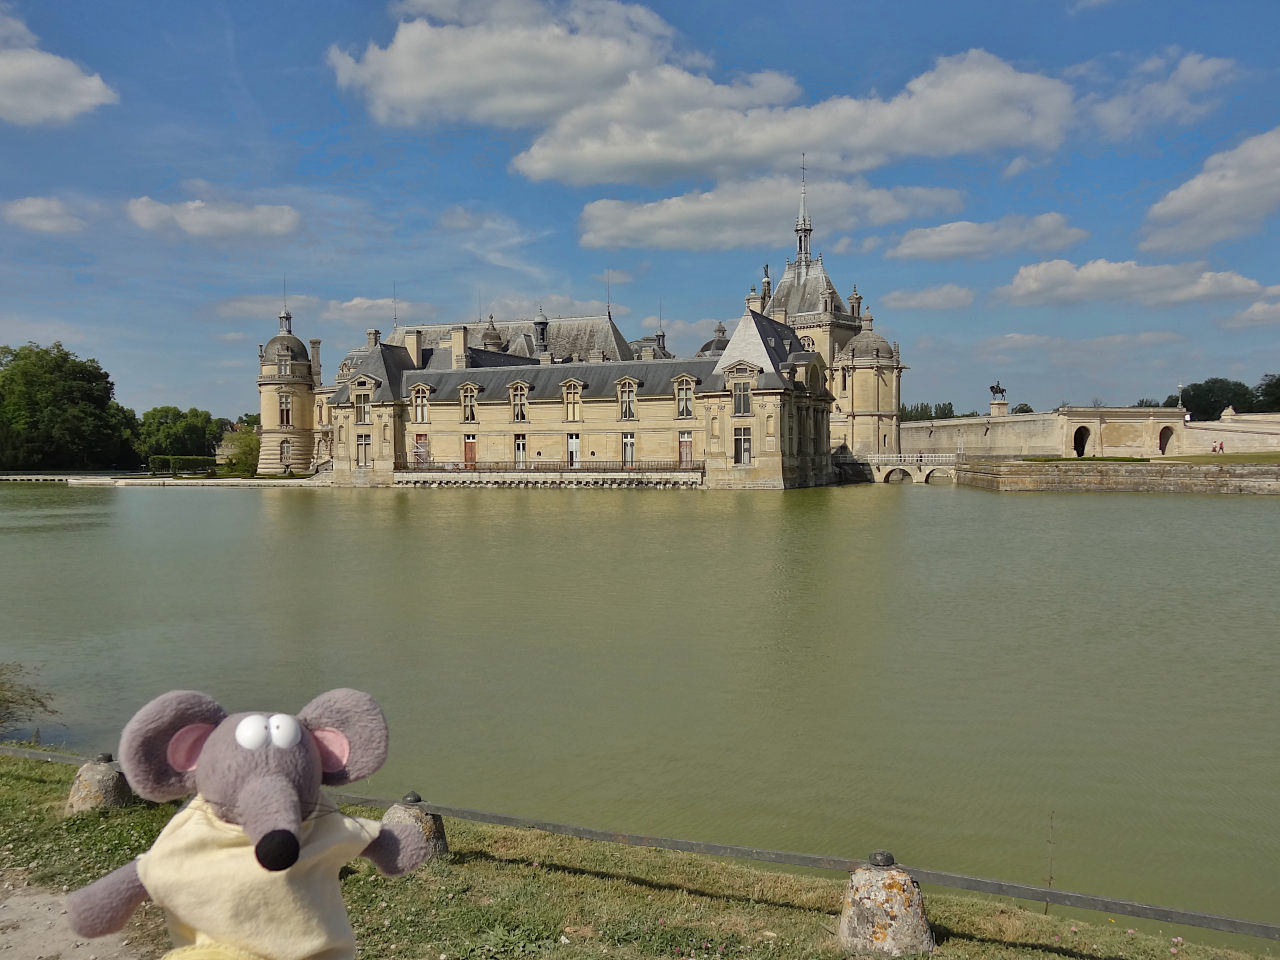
[138,794,381,960]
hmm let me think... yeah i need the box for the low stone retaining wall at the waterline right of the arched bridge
[956,461,1280,494]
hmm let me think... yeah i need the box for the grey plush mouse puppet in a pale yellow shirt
[67,690,426,960]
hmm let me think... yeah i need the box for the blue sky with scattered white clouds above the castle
[0,0,1280,416]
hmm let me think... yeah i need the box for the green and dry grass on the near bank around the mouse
[0,758,1269,960]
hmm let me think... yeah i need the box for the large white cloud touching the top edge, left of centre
[328,0,673,128]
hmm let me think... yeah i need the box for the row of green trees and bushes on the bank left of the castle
[0,342,257,471]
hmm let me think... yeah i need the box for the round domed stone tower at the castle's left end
[257,307,320,474]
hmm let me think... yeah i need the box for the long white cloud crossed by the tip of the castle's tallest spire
[579,177,963,250]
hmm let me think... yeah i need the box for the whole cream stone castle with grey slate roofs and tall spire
[257,188,906,488]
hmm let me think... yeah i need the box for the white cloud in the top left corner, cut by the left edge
[0,6,120,127]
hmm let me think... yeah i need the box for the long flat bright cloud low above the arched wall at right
[996,260,1266,306]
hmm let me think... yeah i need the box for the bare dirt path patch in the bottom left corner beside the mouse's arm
[0,877,159,960]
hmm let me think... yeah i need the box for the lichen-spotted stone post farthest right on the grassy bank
[836,850,936,956]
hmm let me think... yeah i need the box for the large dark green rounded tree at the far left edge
[0,342,138,470]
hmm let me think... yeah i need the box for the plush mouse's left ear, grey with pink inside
[120,690,227,801]
